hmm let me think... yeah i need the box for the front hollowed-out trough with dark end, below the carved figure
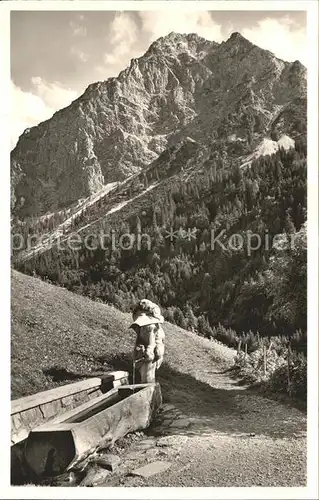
[18,383,162,477]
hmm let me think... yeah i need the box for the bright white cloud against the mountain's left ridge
[10,77,77,148]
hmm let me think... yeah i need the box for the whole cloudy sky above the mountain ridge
[10,10,307,147]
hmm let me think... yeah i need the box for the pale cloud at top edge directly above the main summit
[139,11,224,42]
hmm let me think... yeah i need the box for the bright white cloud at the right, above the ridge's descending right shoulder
[241,16,307,64]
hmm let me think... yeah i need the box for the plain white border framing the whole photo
[0,0,319,499]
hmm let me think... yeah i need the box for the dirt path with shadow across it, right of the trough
[84,334,306,487]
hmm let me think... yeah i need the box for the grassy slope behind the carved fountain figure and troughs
[11,271,234,399]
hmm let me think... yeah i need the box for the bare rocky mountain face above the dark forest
[11,33,306,217]
